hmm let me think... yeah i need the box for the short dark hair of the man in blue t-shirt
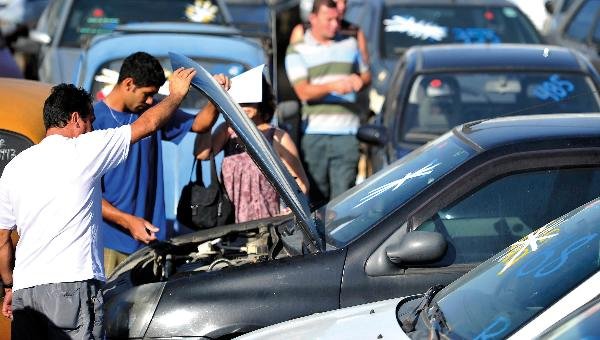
[117,52,167,88]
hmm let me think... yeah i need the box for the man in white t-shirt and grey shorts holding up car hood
[0,69,196,339]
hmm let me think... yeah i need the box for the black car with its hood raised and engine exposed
[104,51,600,339]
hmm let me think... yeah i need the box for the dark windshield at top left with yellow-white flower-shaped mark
[60,0,225,47]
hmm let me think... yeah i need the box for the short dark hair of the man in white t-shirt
[44,84,93,129]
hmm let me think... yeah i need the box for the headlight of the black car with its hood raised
[104,282,166,338]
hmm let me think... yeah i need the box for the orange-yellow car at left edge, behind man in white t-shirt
[0,78,50,339]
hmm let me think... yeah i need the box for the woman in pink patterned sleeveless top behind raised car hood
[195,74,309,223]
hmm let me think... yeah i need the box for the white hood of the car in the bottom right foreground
[236,298,409,340]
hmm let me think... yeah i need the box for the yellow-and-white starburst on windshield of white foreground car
[497,219,563,275]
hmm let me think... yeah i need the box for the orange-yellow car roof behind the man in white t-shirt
[0,78,52,143]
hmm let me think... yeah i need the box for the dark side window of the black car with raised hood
[417,168,600,264]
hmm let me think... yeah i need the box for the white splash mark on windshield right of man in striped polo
[383,15,448,41]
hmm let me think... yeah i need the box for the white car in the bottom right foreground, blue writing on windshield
[238,199,600,340]
